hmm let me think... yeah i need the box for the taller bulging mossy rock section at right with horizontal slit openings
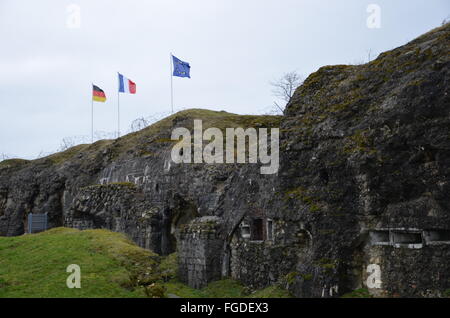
[274,25,450,296]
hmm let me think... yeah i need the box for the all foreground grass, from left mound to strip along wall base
[0,228,289,297]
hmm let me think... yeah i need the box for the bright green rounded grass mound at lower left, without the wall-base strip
[0,228,156,297]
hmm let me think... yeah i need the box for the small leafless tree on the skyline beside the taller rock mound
[270,71,303,113]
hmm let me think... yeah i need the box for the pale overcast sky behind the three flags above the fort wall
[0,0,450,159]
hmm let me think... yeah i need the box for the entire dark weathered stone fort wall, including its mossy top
[0,25,450,297]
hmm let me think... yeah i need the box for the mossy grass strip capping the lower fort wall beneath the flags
[0,108,281,171]
